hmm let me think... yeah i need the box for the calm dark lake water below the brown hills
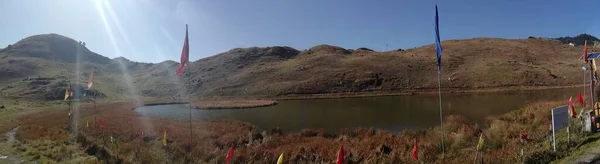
[135,87,581,132]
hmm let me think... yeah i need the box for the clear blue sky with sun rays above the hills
[0,0,600,62]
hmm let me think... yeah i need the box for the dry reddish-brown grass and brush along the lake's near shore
[4,99,588,163]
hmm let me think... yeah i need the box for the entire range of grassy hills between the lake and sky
[0,34,582,100]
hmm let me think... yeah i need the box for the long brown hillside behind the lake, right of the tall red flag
[186,38,581,96]
